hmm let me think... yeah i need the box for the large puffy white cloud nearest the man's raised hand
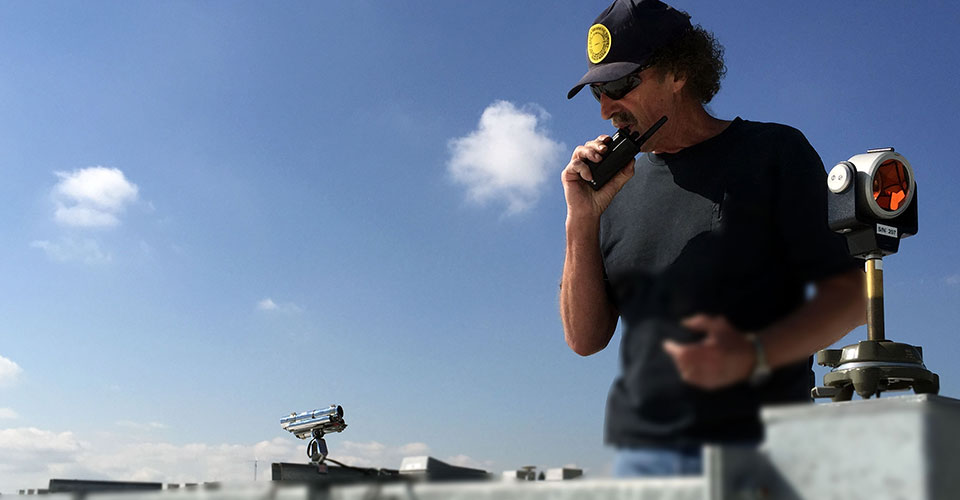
[447,101,565,214]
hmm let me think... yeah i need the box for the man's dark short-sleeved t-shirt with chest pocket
[600,118,858,447]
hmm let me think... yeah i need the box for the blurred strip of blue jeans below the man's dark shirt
[613,447,703,478]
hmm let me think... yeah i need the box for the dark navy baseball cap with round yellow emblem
[567,0,691,99]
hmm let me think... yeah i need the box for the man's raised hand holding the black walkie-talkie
[560,135,636,219]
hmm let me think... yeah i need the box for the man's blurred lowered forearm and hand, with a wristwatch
[664,269,866,389]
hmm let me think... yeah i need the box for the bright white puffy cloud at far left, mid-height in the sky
[53,167,139,227]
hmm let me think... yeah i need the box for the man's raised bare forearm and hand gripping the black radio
[560,135,634,356]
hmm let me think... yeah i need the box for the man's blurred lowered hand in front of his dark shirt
[663,314,756,390]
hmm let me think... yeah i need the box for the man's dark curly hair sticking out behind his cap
[650,25,727,104]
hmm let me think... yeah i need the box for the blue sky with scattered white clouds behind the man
[0,0,960,493]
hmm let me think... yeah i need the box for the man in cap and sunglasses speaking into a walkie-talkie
[560,0,865,476]
